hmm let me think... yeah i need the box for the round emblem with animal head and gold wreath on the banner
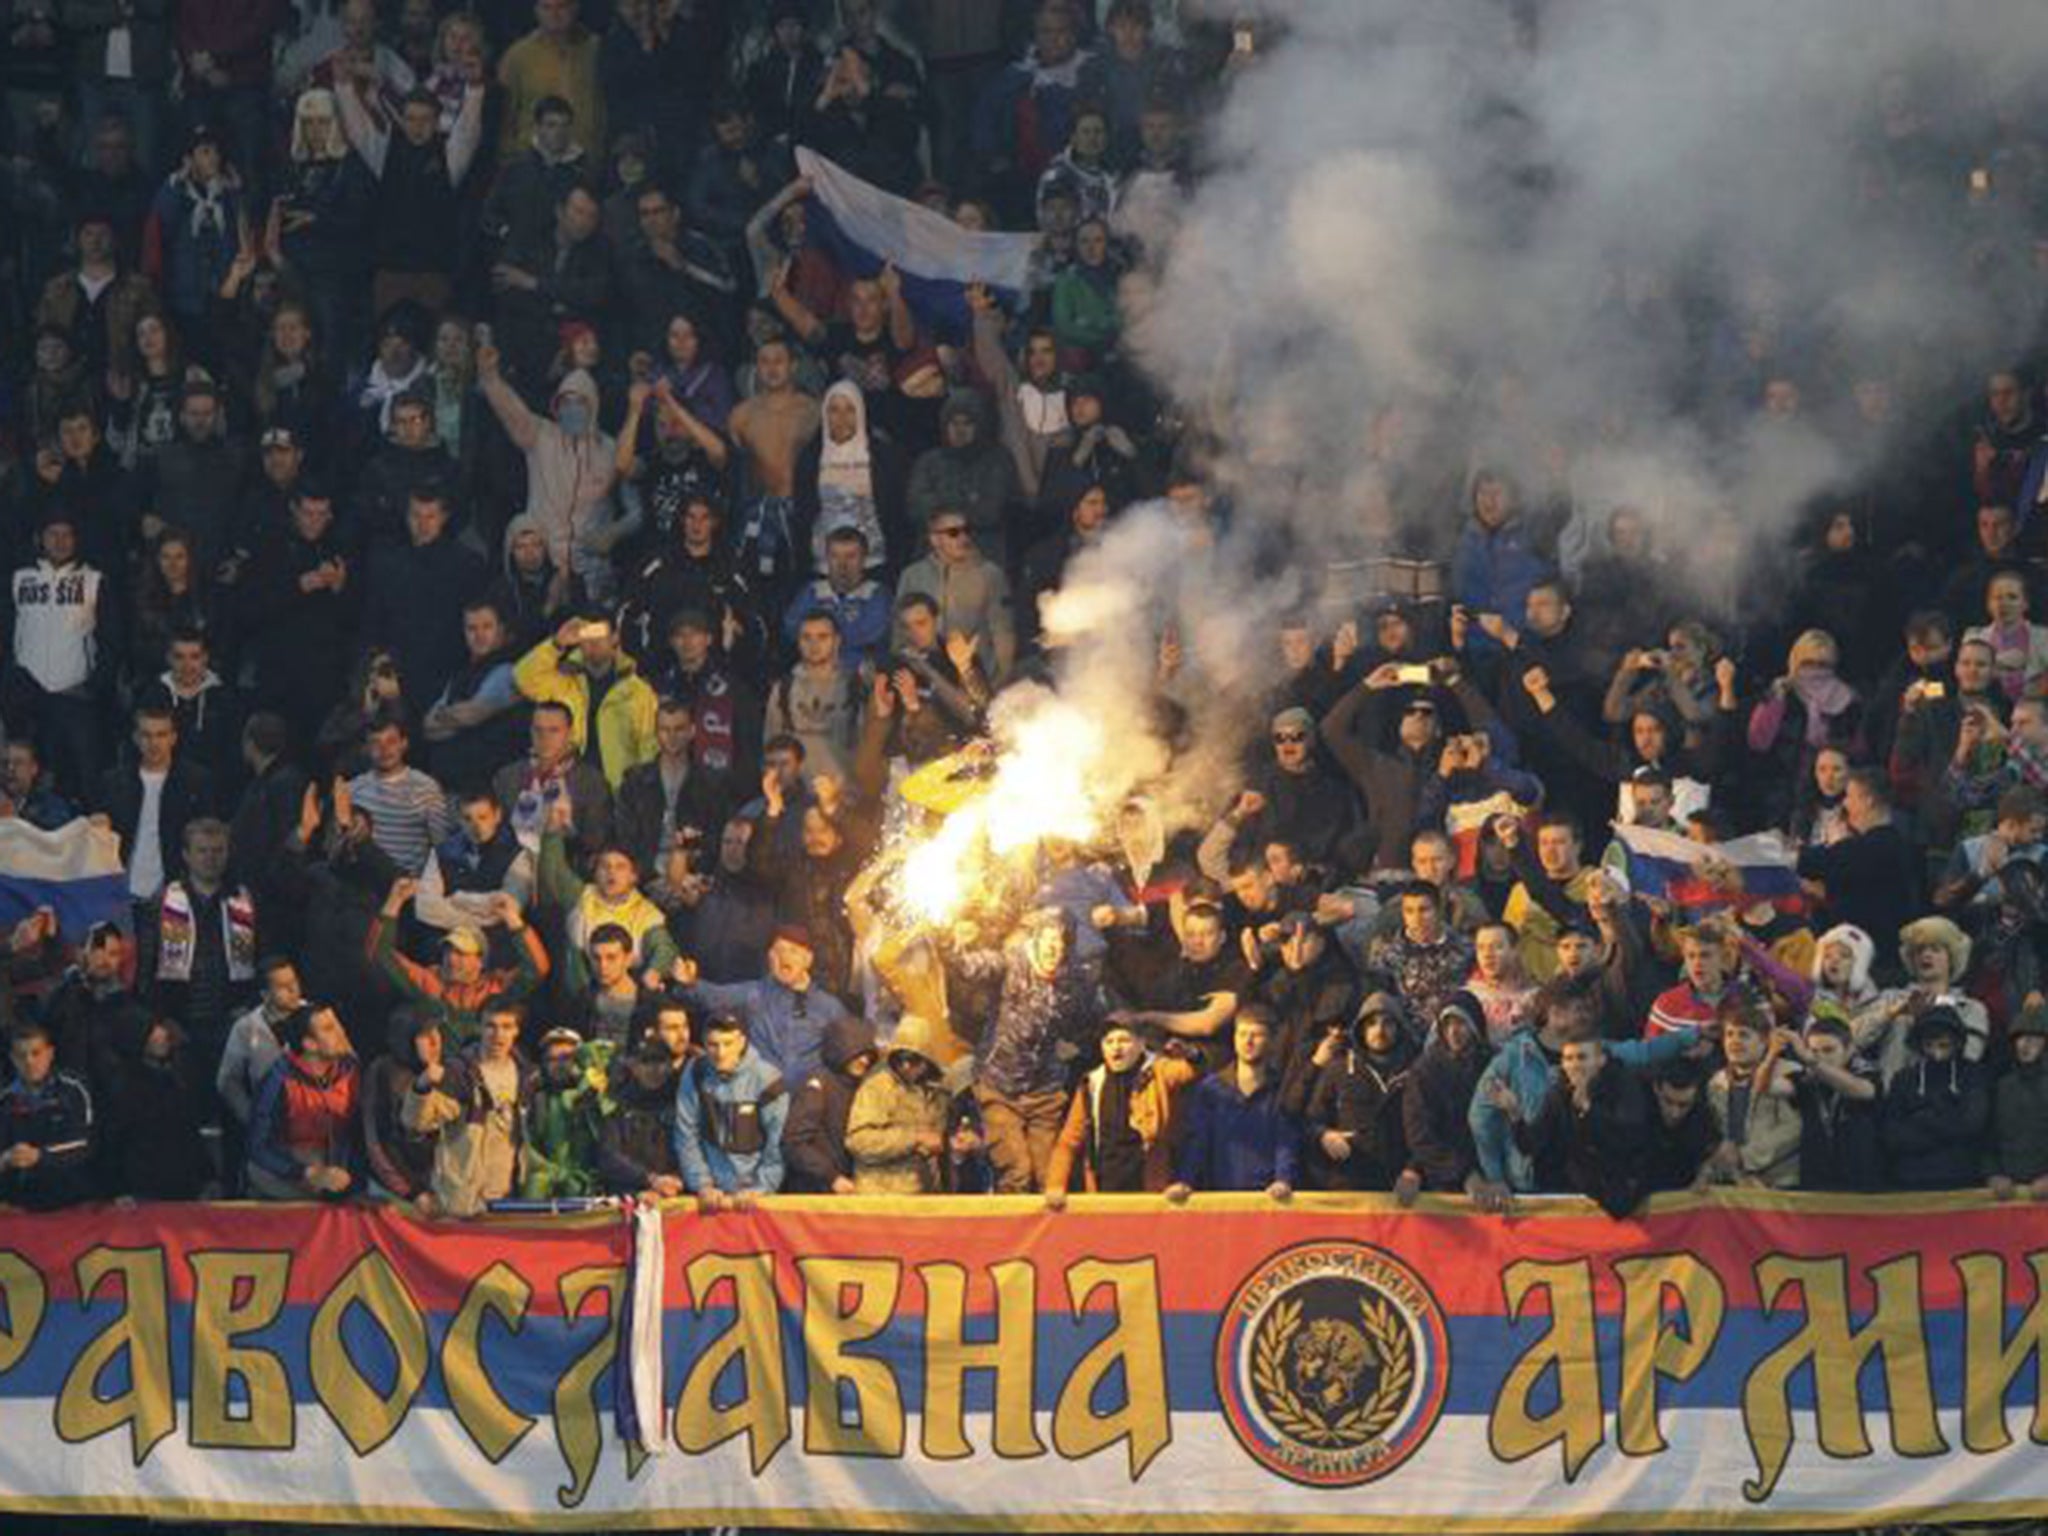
[1217,1243,1450,1489]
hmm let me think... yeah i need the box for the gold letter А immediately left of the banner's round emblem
[1053,1260,1174,1483]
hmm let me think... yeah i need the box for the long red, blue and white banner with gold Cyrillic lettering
[0,1192,2048,1532]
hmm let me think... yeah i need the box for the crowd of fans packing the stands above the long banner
[0,0,2048,1217]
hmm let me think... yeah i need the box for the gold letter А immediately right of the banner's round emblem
[1487,1260,1608,1483]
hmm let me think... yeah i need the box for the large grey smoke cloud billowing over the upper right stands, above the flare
[1130,0,2048,581]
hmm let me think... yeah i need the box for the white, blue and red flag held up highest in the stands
[797,145,1038,342]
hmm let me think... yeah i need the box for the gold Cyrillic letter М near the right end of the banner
[1743,1253,1948,1503]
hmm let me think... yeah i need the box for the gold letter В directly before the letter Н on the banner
[797,1260,903,1456]
